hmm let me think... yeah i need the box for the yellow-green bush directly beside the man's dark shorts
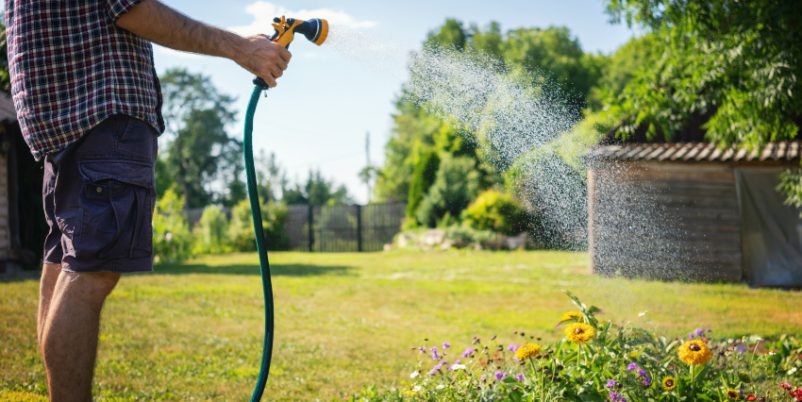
[153,188,192,263]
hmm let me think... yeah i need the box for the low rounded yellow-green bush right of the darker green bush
[462,190,529,236]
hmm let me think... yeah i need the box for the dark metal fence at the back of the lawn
[286,203,406,251]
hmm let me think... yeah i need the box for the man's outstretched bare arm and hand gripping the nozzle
[116,0,290,87]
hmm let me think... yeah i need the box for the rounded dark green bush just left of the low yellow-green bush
[416,156,480,227]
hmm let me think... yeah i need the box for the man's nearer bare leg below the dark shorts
[42,271,120,402]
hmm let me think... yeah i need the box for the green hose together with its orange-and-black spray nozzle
[242,16,329,402]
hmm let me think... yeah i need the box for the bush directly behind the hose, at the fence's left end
[228,200,289,251]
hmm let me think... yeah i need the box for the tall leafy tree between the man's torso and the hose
[157,69,245,208]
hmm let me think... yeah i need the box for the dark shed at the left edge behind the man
[0,92,46,274]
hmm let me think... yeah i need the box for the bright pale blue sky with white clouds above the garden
[10,0,633,202]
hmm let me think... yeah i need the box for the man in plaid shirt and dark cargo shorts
[6,0,290,402]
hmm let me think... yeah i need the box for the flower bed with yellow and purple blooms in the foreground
[353,293,802,402]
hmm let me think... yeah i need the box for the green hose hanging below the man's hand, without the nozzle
[242,83,273,402]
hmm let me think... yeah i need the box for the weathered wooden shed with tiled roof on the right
[588,141,802,287]
